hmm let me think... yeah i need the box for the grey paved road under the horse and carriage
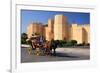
[21,48,90,63]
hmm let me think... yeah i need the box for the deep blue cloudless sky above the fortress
[21,10,90,33]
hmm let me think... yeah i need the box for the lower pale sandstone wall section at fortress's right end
[71,24,90,43]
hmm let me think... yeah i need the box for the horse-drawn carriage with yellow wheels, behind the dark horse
[28,35,52,55]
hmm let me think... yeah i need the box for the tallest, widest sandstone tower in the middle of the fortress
[54,14,68,40]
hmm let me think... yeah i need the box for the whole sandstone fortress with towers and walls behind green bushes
[27,14,90,44]
